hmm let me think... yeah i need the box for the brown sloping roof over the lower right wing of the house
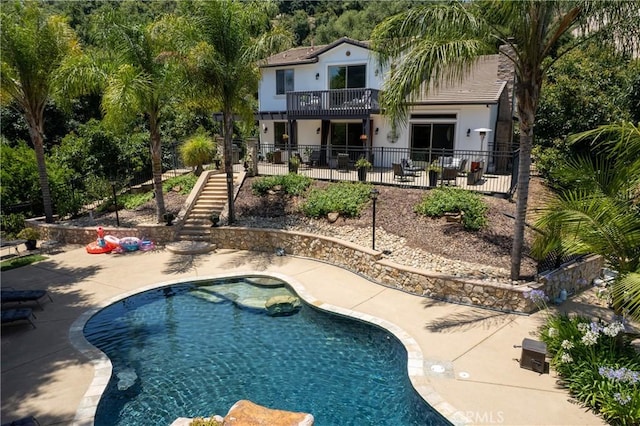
[412,55,507,105]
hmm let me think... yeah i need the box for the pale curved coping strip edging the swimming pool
[69,271,472,426]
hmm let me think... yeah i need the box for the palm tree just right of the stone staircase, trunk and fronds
[178,0,292,223]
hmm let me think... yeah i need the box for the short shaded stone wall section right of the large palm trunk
[538,255,604,300]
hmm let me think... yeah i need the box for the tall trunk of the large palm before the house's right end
[511,73,540,280]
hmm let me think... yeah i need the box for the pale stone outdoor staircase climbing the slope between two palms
[178,173,227,241]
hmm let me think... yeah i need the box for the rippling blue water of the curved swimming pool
[84,277,450,426]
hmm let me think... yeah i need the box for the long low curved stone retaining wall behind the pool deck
[27,220,602,313]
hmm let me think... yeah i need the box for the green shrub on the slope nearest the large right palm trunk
[413,188,487,231]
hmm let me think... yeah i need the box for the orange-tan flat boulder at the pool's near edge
[222,400,314,426]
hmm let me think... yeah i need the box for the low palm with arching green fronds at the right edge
[533,123,640,320]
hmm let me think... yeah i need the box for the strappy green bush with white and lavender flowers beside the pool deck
[540,314,640,425]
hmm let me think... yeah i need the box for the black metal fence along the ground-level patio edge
[248,144,518,194]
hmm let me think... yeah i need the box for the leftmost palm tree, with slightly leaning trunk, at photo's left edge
[0,2,80,223]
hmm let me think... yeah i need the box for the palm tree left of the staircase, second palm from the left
[82,13,180,222]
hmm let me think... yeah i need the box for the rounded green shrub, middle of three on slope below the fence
[302,182,372,218]
